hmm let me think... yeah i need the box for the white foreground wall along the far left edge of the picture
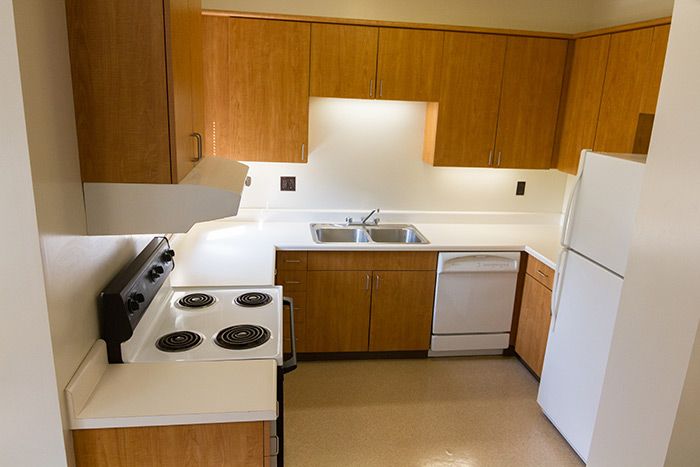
[0,0,66,467]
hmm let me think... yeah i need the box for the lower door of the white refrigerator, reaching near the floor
[537,252,623,461]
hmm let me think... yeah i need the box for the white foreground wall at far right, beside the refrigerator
[589,0,700,467]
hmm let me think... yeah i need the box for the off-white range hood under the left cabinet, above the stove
[83,157,248,235]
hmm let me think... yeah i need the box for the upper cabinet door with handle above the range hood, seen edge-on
[165,0,204,183]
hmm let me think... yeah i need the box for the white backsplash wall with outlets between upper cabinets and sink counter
[241,98,566,213]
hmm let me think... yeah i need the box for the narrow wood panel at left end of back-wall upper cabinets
[202,15,233,157]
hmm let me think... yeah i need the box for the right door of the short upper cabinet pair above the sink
[377,28,445,101]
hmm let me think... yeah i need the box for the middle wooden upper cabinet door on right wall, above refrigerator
[594,28,654,152]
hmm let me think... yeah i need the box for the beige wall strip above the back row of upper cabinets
[202,0,673,33]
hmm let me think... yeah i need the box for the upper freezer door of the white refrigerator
[562,152,644,277]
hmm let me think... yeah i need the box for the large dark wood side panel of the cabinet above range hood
[66,0,171,183]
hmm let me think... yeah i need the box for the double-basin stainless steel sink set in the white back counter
[311,224,429,244]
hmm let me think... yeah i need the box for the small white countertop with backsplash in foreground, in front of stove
[65,340,277,430]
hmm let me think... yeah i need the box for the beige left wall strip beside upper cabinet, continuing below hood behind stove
[14,0,148,464]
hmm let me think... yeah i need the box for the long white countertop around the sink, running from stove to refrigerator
[170,220,561,287]
